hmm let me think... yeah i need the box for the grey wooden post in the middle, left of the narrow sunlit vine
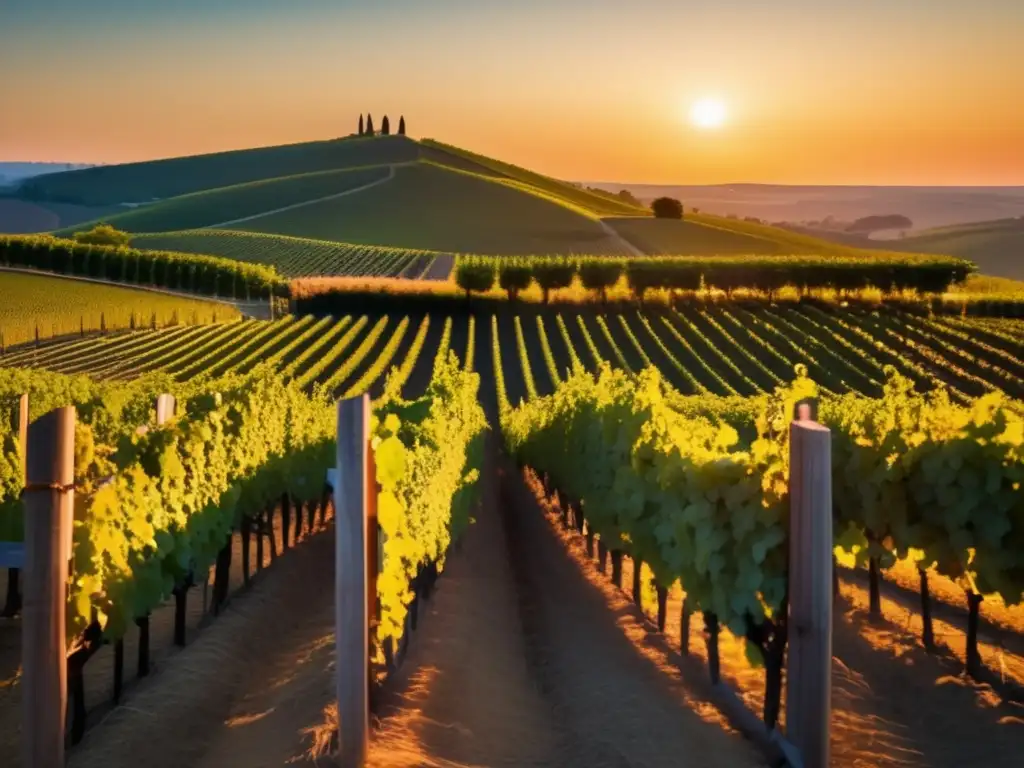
[334,394,376,768]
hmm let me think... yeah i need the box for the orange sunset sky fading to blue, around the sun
[6,0,1024,184]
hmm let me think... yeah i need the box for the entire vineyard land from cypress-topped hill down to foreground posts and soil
[6,128,1024,768]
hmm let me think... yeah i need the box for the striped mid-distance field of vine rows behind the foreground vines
[0,303,1024,415]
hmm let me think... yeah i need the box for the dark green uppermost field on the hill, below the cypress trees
[17,136,419,205]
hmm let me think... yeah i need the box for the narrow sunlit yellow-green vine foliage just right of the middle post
[371,350,486,647]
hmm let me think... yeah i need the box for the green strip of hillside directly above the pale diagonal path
[57,165,389,236]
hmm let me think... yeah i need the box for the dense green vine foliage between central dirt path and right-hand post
[502,364,787,635]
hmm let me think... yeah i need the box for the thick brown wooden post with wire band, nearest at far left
[22,408,75,768]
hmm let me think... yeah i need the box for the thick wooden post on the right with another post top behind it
[785,404,833,768]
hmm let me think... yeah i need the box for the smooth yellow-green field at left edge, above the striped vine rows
[0,272,240,346]
